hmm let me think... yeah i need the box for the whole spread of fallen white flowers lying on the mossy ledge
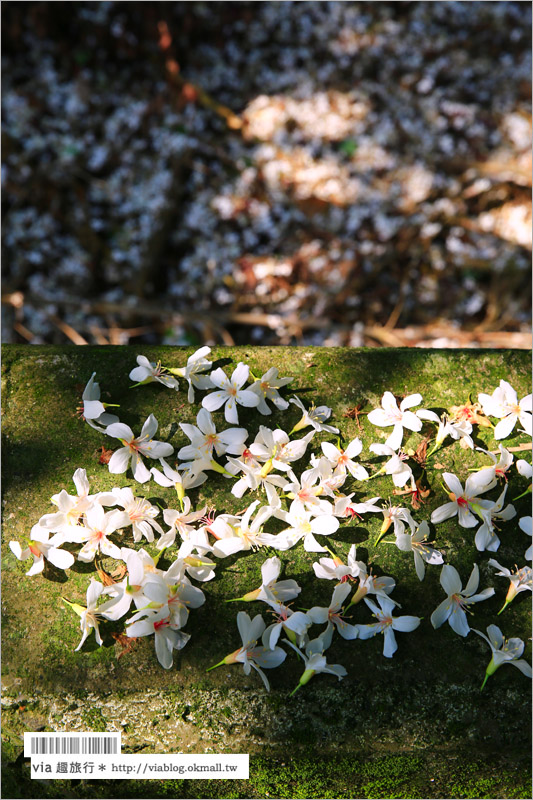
[10,347,532,693]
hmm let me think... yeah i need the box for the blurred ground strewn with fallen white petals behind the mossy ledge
[2,2,532,348]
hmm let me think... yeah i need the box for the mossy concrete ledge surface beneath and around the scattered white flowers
[2,346,531,797]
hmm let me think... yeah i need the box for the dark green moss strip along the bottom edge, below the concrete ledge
[3,753,531,799]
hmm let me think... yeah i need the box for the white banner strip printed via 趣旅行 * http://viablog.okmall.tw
[31,753,249,780]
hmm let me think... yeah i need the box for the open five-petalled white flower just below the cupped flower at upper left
[105,414,170,483]
